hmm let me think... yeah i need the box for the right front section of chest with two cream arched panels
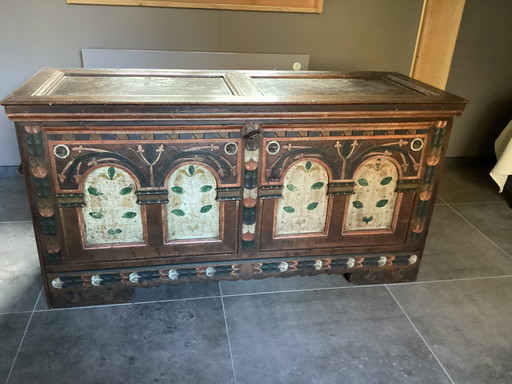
[261,123,432,249]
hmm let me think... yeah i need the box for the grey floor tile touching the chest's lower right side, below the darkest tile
[418,206,512,281]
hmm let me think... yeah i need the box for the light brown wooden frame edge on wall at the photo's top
[67,0,323,13]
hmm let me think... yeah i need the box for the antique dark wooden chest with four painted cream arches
[2,69,465,307]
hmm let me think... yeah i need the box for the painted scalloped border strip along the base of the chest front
[50,253,419,289]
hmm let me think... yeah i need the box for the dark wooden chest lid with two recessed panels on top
[1,68,465,115]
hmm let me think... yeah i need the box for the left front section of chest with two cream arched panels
[45,126,242,263]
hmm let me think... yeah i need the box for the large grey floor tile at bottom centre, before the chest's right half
[224,287,450,384]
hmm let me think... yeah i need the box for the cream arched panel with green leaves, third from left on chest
[275,160,329,235]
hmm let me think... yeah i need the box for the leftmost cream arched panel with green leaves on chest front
[82,166,144,246]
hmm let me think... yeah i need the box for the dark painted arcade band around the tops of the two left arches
[48,135,242,194]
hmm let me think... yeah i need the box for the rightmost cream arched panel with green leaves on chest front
[345,157,398,231]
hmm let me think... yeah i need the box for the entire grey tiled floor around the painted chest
[0,166,512,384]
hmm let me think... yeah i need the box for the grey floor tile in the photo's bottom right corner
[389,278,512,384]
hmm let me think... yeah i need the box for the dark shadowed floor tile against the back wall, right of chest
[438,165,504,203]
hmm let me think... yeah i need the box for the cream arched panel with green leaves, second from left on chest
[167,164,220,240]
